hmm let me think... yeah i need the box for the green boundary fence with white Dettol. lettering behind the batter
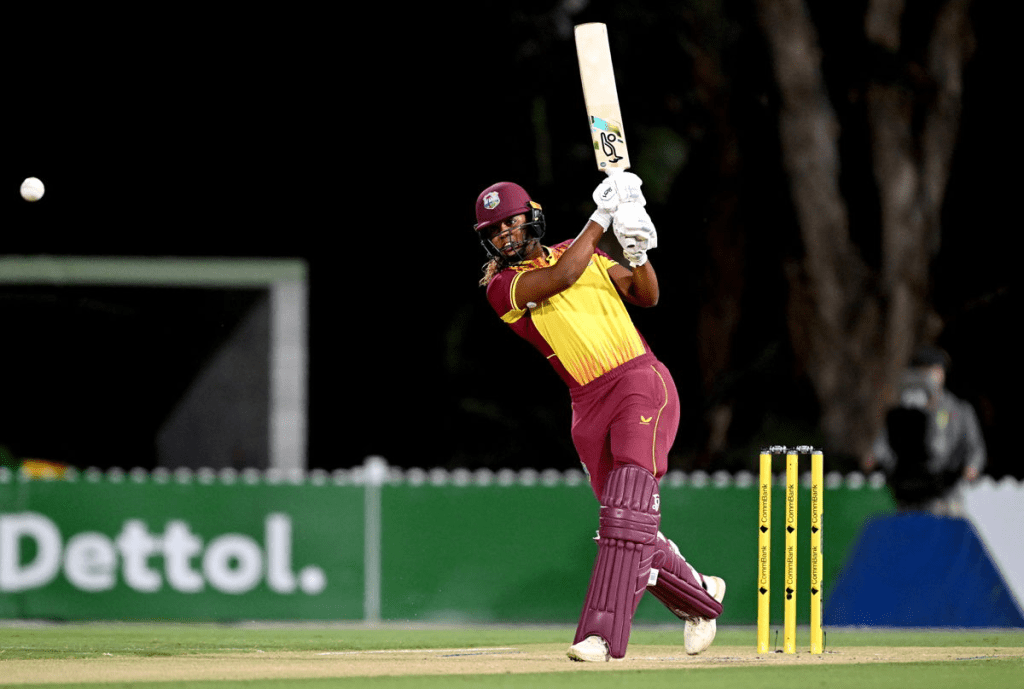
[0,462,893,625]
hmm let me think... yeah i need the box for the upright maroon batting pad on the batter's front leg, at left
[572,465,662,658]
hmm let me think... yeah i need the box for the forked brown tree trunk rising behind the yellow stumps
[758,0,971,458]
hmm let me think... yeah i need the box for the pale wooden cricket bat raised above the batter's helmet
[575,23,630,174]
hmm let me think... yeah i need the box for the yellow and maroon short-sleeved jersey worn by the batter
[487,241,648,388]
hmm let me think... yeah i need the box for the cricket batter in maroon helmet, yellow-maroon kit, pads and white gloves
[475,172,725,661]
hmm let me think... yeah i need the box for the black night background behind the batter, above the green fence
[0,0,1024,476]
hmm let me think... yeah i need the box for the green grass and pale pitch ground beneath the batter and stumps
[0,623,1024,689]
